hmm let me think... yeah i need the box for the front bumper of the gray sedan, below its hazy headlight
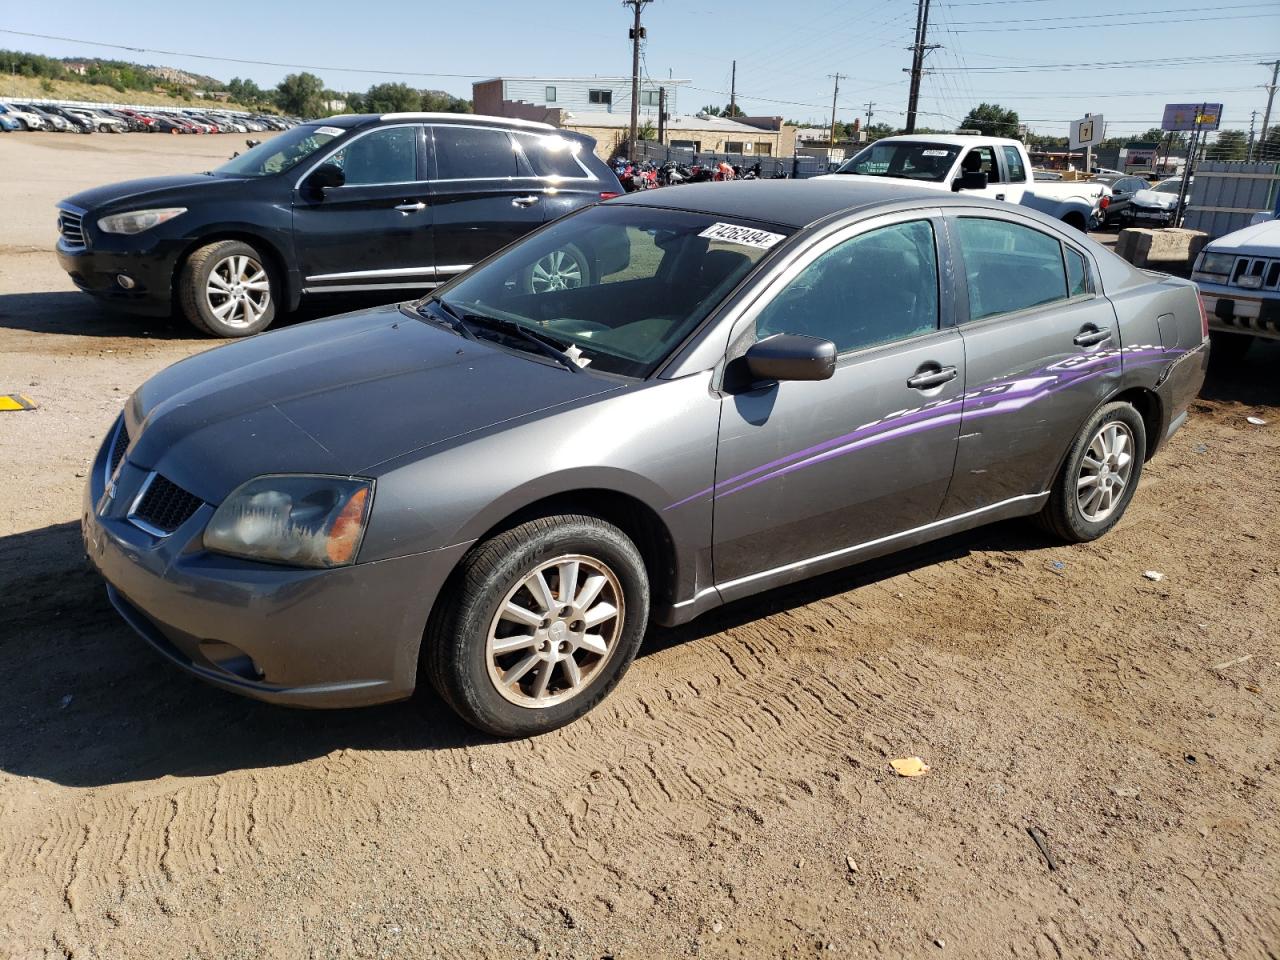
[81,424,466,707]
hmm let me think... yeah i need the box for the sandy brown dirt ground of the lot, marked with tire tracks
[0,134,1280,959]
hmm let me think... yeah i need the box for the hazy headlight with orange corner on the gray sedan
[205,474,374,567]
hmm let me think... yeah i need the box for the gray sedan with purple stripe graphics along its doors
[83,182,1208,736]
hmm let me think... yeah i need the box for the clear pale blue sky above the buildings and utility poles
[0,0,1280,136]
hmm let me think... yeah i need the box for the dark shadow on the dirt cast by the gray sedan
[0,512,1048,787]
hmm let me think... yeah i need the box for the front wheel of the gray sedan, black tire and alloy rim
[419,515,649,737]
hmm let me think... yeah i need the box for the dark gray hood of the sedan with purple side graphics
[125,305,623,503]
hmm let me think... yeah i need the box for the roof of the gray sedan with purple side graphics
[608,177,1038,228]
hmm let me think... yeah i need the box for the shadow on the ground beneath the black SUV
[0,291,407,346]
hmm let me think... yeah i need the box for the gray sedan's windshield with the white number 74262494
[415,204,791,378]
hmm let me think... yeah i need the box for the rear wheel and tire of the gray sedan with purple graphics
[1038,402,1147,543]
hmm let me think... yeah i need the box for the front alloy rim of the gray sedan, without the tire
[485,554,626,708]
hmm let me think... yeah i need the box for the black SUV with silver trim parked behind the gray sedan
[58,114,622,337]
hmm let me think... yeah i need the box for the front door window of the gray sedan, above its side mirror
[755,220,938,353]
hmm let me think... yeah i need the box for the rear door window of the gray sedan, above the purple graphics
[955,216,1068,320]
